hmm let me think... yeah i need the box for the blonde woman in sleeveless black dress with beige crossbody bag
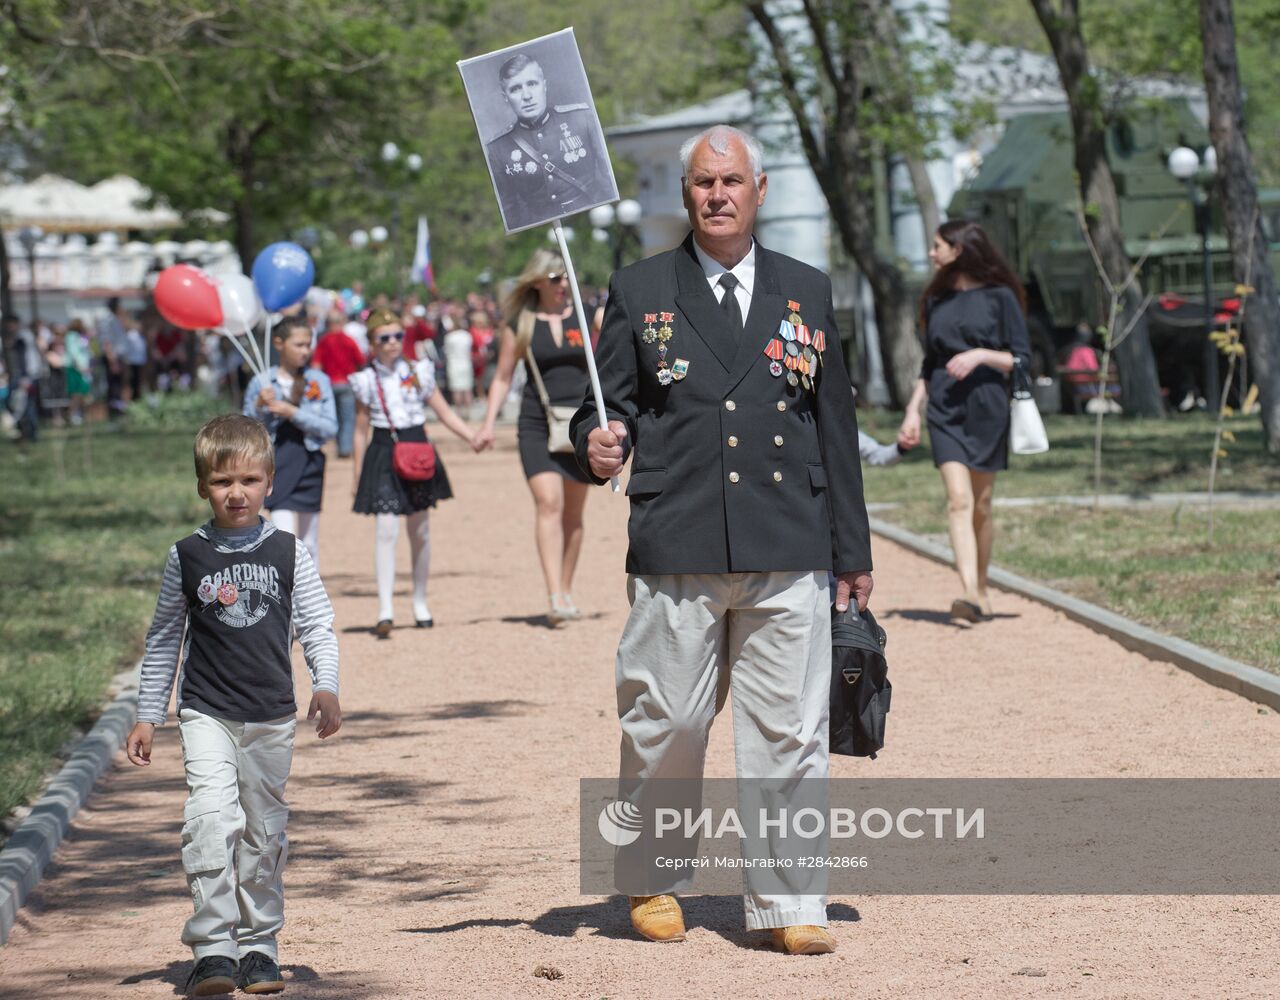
[477,250,601,625]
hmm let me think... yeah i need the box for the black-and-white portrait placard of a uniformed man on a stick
[458,28,618,233]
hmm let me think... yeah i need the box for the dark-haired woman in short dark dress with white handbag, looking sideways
[897,219,1030,621]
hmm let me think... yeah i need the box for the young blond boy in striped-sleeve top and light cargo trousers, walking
[125,415,342,996]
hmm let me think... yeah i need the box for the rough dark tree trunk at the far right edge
[1201,0,1280,455]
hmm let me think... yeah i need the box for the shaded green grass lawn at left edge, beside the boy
[0,396,224,817]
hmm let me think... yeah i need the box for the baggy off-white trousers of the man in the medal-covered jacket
[617,570,831,930]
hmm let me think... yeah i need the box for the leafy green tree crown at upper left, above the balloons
[9,0,465,265]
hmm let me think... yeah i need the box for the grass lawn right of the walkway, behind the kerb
[864,404,1280,673]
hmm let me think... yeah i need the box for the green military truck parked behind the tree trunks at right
[948,100,1280,408]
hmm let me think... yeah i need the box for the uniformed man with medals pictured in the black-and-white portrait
[486,52,614,229]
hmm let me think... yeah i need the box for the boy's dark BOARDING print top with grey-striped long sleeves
[138,522,338,726]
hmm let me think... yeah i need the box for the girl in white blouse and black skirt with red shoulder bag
[351,309,485,639]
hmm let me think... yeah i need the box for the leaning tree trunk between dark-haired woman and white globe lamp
[1030,0,1165,416]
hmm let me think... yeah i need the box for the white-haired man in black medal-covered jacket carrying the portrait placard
[571,125,872,954]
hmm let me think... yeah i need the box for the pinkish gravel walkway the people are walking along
[0,430,1280,1000]
